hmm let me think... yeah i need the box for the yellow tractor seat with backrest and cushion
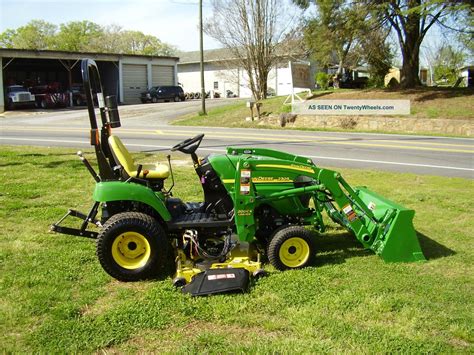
[109,135,170,179]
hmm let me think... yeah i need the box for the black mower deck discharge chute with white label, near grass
[181,268,250,296]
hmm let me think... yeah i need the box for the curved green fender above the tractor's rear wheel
[92,181,171,222]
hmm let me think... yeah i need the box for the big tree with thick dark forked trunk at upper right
[366,0,468,88]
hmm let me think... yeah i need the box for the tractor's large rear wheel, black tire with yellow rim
[97,212,169,281]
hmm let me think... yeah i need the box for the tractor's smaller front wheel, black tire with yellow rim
[268,226,315,270]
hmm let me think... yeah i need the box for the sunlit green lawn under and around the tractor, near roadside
[0,146,474,353]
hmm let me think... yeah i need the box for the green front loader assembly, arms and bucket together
[233,149,425,262]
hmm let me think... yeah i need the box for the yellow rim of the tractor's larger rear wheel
[112,232,151,270]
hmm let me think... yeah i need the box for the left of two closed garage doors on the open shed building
[122,64,148,104]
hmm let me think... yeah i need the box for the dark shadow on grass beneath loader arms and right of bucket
[314,232,456,266]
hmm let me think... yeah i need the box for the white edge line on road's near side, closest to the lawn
[0,137,474,171]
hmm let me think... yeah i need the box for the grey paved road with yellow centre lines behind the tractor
[0,100,474,179]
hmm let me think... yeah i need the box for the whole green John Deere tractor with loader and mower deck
[52,59,424,295]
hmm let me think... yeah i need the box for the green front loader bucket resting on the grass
[355,187,426,262]
